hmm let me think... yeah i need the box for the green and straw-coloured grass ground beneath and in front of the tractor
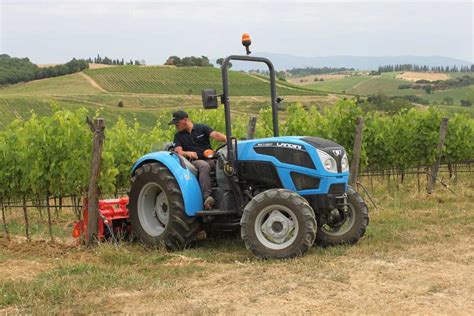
[0,175,474,314]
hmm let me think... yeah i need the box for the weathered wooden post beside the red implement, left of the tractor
[86,117,105,247]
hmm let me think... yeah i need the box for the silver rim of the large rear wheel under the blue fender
[138,182,169,237]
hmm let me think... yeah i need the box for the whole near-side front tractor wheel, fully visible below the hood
[240,189,317,259]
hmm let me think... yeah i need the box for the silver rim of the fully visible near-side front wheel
[254,205,299,250]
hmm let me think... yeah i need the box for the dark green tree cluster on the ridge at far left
[0,54,89,85]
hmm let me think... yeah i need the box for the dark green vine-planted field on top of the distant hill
[85,66,322,96]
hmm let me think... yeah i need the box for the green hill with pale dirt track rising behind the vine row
[0,66,335,129]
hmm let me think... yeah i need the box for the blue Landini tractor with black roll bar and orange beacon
[128,37,369,258]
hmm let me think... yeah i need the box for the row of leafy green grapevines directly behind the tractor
[0,101,474,205]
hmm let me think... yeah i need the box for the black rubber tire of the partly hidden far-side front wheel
[316,186,369,247]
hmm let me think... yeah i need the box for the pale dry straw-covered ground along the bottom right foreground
[85,239,474,314]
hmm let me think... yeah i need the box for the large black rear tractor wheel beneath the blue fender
[128,163,200,250]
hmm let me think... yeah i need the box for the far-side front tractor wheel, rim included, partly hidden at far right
[316,186,369,247]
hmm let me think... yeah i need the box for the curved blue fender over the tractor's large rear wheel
[132,151,204,216]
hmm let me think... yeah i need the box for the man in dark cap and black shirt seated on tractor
[169,110,227,210]
